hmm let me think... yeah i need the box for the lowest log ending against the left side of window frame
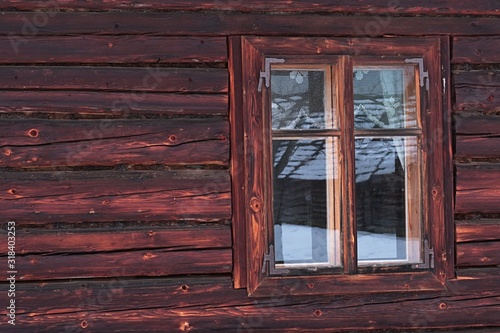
[0,248,232,281]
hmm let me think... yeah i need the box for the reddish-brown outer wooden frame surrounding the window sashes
[229,37,454,296]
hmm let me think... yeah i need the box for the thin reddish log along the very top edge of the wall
[0,0,500,15]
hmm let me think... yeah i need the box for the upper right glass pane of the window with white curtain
[353,66,418,129]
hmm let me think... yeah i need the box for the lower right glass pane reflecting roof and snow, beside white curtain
[355,137,421,264]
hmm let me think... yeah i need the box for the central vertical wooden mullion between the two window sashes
[336,56,358,274]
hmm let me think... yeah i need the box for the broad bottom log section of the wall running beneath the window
[0,269,500,332]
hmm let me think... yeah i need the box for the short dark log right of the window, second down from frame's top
[453,70,500,111]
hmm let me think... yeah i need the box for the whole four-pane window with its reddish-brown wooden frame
[233,37,453,295]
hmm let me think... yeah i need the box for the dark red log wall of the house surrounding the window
[0,0,500,332]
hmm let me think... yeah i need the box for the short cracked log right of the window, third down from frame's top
[455,114,500,158]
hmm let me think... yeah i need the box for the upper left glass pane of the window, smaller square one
[271,66,332,130]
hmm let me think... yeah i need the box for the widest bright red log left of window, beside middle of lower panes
[0,170,231,223]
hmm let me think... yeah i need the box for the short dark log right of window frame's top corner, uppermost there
[451,36,500,64]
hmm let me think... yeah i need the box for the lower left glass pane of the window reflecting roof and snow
[273,138,340,267]
